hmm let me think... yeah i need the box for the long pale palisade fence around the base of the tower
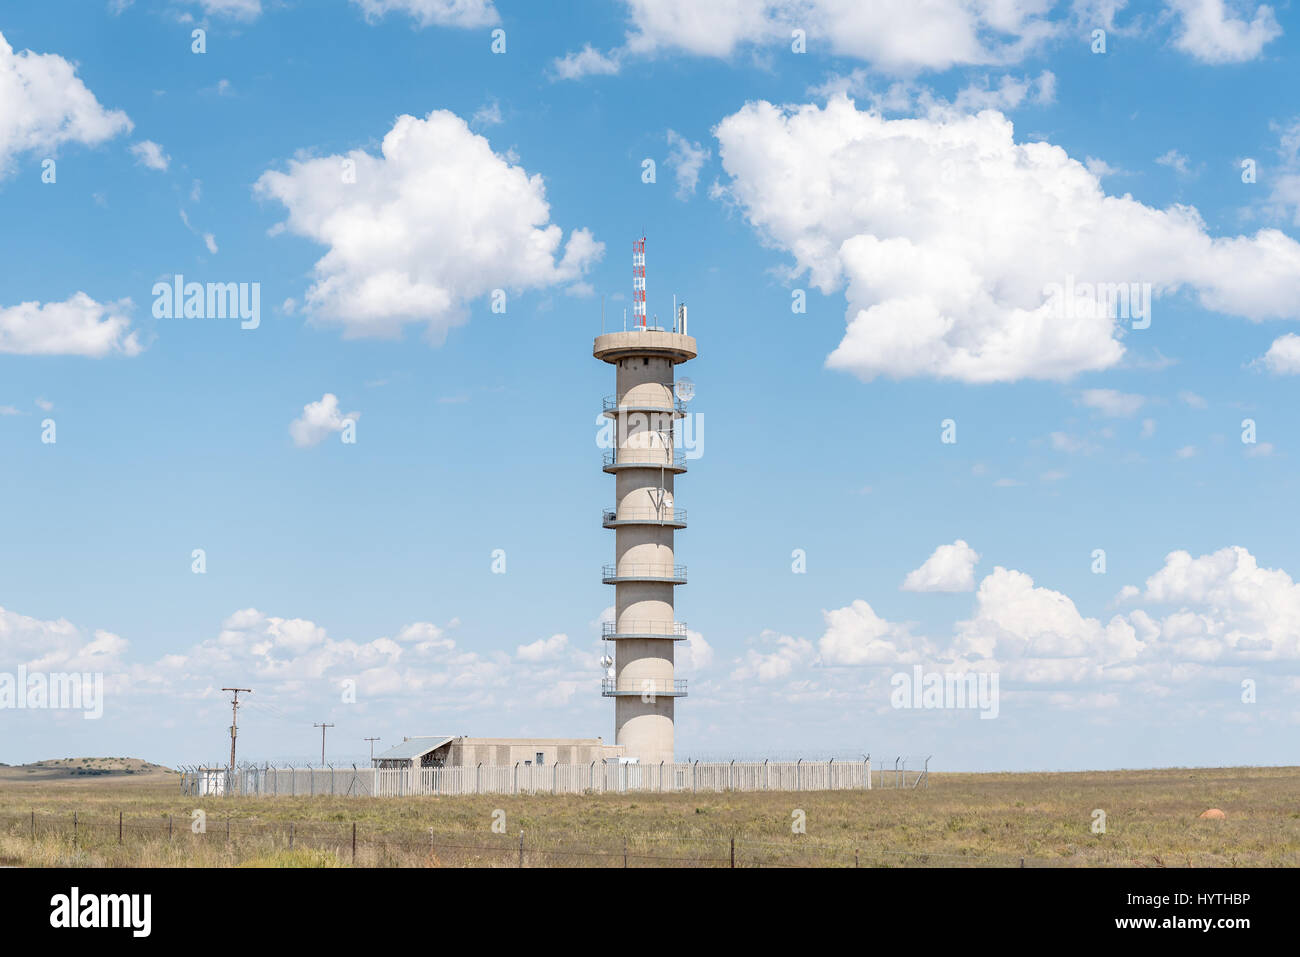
[181,759,883,797]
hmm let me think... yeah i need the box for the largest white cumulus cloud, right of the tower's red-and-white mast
[715,96,1300,382]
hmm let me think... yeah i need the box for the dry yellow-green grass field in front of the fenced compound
[0,759,1300,867]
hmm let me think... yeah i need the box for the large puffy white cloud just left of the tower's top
[255,111,605,343]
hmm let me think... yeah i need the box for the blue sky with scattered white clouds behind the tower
[0,0,1300,770]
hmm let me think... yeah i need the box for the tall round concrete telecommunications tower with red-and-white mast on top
[592,237,696,765]
